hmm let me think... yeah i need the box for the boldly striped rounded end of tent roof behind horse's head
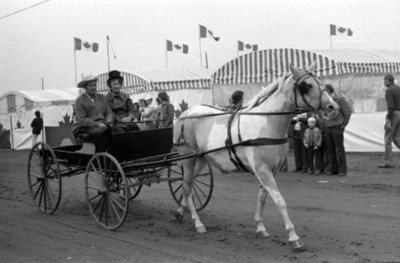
[212,49,337,85]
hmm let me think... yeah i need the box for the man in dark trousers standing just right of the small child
[325,84,351,177]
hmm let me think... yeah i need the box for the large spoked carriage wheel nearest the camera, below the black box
[85,153,129,230]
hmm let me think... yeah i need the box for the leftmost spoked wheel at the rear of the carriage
[28,142,61,215]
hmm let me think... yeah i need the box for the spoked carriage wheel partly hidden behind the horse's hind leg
[168,163,214,211]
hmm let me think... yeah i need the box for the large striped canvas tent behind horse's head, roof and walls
[211,49,400,151]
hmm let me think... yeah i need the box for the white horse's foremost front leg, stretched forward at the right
[256,164,305,251]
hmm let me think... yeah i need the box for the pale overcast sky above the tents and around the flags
[0,0,400,95]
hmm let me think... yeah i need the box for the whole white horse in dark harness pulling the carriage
[174,65,338,251]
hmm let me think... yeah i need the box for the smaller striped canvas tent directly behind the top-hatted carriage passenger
[97,70,212,114]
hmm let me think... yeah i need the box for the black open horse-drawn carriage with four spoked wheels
[27,128,213,230]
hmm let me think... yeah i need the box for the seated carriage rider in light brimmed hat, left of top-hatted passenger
[72,75,113,152]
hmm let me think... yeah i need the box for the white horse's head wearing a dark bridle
[290,62,339,113]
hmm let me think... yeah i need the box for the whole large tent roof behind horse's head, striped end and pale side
[212,48,400,85]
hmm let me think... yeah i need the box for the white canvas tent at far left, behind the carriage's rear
[0,88,79,150]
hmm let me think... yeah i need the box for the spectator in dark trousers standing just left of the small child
[292,113,308,173]
